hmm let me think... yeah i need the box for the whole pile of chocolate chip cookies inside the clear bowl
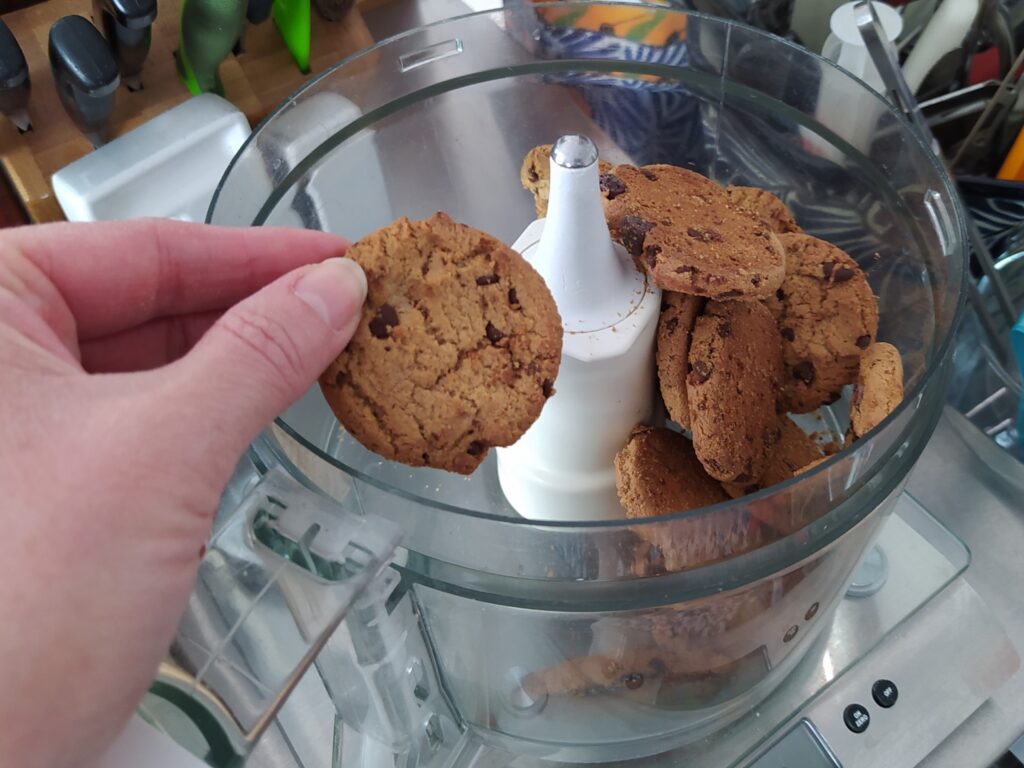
[523,147,902,532]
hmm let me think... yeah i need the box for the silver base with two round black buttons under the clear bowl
[119,473,1020,768]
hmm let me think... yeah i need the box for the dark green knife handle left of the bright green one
[175,0,248,96]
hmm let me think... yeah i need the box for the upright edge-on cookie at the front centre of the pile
[686,301,782,485]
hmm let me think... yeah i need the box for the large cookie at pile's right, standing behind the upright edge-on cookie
[777,233,879,414]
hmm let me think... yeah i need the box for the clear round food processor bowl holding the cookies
[201,3,966,762]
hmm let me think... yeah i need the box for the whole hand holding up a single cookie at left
[0,221,366,768]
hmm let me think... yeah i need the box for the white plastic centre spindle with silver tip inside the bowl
[497,136,662,521]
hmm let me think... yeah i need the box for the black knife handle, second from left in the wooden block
[49,16,121,146]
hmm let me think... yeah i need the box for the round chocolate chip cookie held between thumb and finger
[321,213,562,474]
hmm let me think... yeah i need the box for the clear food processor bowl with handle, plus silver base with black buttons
[132,3,1018,767]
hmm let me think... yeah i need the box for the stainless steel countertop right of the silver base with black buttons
[907,408,1024,768]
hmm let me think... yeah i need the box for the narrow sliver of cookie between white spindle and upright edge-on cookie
[655,291,705,429]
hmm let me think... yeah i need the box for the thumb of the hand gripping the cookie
[175,258,367,461]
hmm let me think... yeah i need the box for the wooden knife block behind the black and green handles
[0,0,374,222]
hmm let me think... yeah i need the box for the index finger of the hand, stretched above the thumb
[4,219,348,339]
